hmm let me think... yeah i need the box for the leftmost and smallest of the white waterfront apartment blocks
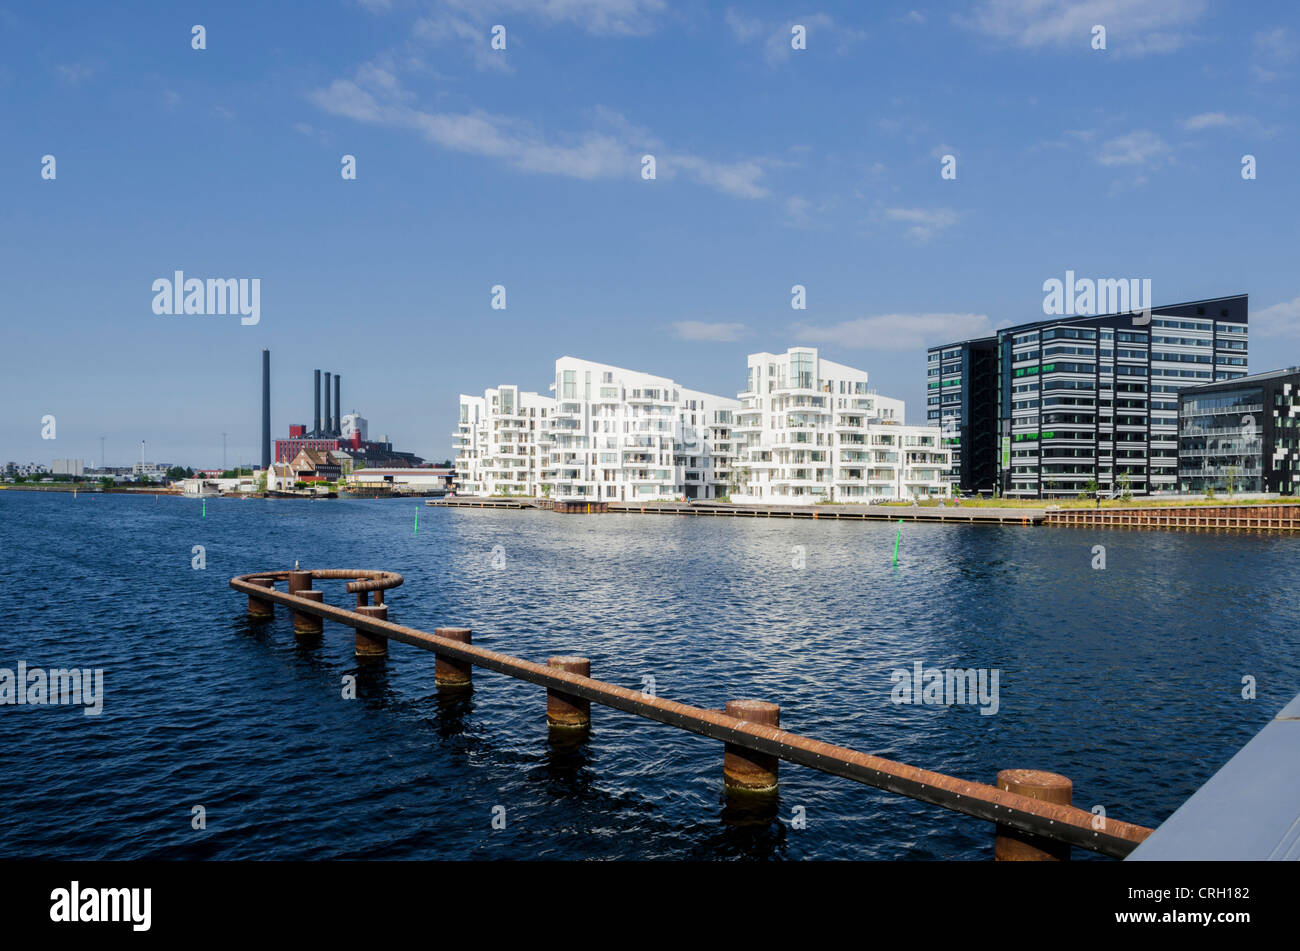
[451,385,555,498]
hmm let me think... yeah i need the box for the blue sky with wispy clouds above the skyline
[0,0,1300,466]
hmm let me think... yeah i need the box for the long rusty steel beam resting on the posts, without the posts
[230,570,1153,857]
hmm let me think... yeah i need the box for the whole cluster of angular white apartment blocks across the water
[452,347,949,503]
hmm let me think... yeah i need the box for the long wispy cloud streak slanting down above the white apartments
[308,64,770,199]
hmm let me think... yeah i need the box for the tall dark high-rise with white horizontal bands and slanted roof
[927,295,1248,498]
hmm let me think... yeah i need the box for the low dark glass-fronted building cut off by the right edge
[1178,366,1300,495]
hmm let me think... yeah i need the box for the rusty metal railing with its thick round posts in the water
[230,569,1152,860]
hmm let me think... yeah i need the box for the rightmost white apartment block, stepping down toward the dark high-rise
[731,347,952,504]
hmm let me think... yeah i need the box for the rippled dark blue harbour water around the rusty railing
[0,492,1300,859]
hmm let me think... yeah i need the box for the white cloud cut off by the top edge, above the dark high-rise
[954,0,1206,56]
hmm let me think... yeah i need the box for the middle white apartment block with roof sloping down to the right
[550,356,740,501]
